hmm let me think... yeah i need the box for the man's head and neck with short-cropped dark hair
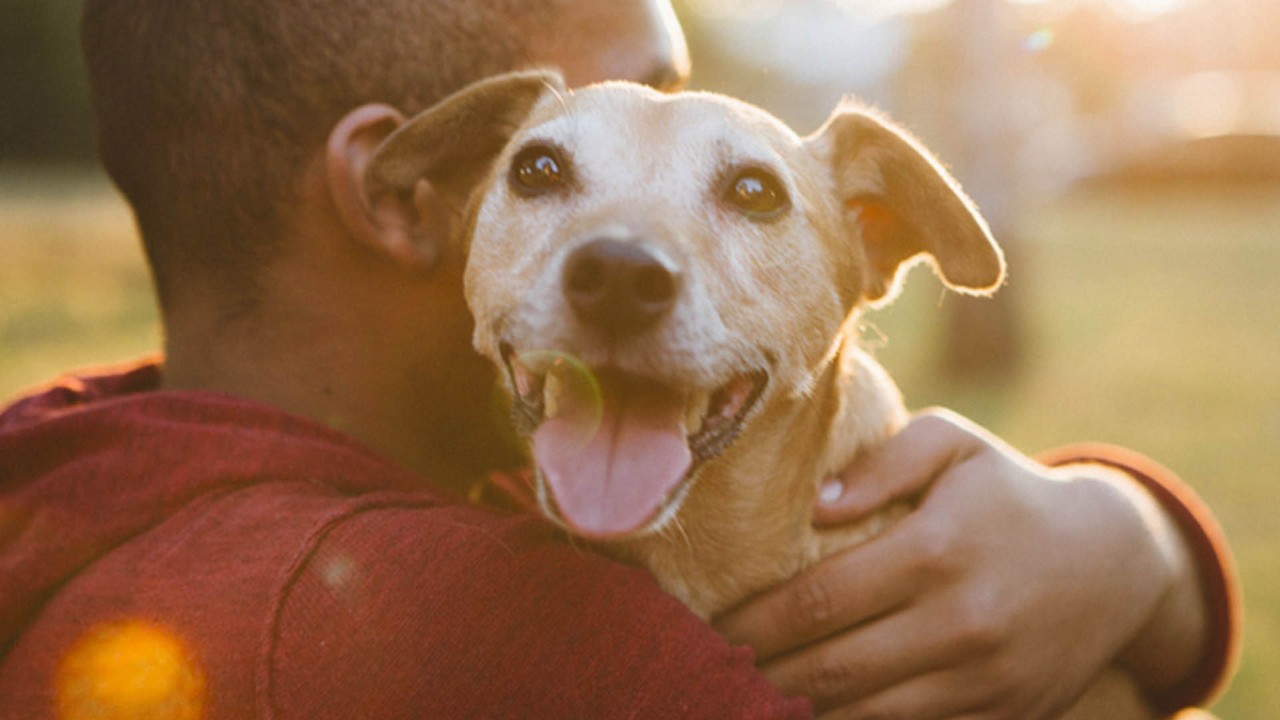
[82,0,689,480]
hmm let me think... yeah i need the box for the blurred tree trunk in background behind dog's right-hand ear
[897,0,1036,380]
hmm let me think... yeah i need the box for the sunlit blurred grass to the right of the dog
[872,181,1280,720]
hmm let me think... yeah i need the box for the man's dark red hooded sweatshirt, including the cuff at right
[0,365,1239,720]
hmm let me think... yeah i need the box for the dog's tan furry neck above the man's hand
[603,337,906,618]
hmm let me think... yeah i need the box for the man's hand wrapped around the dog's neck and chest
[716,413,1199,720]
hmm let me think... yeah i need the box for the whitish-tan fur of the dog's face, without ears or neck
[466,83,842,391]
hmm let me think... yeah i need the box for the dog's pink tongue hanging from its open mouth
[534,378,692,538]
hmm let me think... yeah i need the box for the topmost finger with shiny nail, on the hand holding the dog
[814,410,995,527]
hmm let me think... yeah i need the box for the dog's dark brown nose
[562,240,680,336]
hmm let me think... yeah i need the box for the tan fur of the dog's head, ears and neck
[367,73,1146,717]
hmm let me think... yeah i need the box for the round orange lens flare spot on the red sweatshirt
[56,621,205,720]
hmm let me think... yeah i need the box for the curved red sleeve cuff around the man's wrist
[1039,443,1243,714]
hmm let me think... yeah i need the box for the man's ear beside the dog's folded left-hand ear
[325,104,449,270]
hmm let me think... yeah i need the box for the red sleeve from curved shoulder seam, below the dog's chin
[268,499,812,720]
